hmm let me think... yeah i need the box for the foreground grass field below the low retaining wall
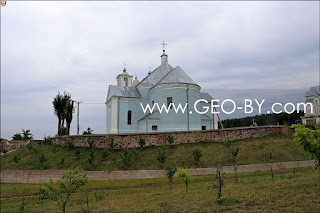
[1,167,320,212]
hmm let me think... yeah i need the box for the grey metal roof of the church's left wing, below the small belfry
[107,85,142,101]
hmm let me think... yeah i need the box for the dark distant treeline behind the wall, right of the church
[222,111,304,128]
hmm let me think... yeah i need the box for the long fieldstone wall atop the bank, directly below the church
[52,126,288,149]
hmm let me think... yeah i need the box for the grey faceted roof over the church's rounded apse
[157,66,196,85]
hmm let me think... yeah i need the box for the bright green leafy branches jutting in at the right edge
[291,124,320,169]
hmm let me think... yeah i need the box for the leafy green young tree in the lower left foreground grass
[38,168,89,213]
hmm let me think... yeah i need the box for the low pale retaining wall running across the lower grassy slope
[0,160,315,183]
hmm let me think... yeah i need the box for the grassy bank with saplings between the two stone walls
[1,134,309,171]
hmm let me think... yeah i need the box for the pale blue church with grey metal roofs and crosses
[105,42,218,133]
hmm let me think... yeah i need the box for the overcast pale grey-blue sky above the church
[1,1,320,139]
